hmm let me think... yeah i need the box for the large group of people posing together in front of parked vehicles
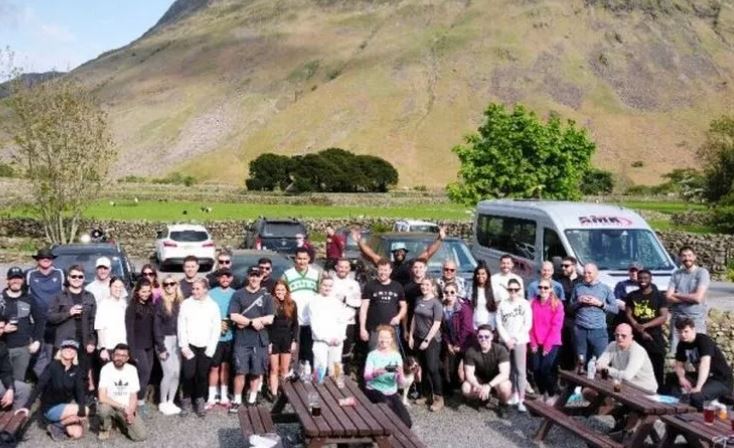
[0,230,732,440]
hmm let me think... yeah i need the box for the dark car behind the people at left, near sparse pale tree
[51,243,135,287]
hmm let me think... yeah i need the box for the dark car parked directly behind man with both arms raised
[367,232,477,282]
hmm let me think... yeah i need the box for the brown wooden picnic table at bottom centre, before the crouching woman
[272,378,394,448]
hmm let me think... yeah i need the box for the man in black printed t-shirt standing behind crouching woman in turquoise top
[359,258,408,350]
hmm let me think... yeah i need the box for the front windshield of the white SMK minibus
[566,229,674,271]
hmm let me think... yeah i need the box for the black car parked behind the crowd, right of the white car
[245,218,306,255]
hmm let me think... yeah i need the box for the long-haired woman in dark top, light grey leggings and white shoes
[153,275,183,415]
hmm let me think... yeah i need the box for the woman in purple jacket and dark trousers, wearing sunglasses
[441,283,474,389]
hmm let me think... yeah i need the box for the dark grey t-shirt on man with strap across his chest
[229,288,275,347]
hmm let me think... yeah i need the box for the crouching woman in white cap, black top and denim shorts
[18,339,88,440]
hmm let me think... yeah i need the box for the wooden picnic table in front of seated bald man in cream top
[533,370,695,447]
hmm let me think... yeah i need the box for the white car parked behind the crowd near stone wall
[155,224,215,268]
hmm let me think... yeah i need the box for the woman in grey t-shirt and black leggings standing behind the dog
[408,278,442,412]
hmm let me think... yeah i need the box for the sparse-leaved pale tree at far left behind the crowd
[8,77,117,244]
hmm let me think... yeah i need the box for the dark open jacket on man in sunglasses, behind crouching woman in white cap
[48,289,97,350]
